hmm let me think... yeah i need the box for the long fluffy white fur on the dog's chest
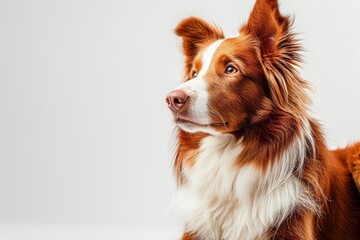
[173,135,313,240]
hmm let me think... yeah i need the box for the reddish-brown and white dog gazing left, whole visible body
[166,0,360,240]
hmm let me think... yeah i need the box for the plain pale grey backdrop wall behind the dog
[0,0,360,239]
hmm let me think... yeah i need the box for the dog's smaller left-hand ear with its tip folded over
[175,17,224,70]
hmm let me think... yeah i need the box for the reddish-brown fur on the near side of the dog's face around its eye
[205,36,271,134]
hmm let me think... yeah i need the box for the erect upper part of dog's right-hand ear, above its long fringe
[240,0,290,55]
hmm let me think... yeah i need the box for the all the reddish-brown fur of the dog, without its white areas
[174,0,360,240]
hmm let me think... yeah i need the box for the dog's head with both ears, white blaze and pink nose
[166,0,308,134]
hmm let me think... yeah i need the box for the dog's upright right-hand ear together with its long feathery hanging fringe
[240,0,310,110]
